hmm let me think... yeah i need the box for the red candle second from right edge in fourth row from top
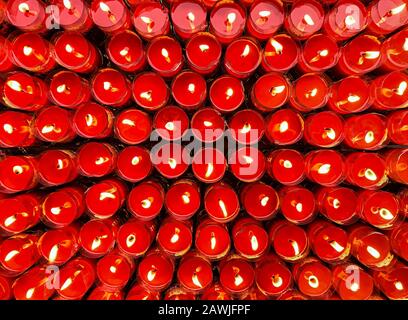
[344,113,388,150]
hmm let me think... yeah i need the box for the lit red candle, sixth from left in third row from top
[209,75,245,112]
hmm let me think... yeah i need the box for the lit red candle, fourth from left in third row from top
[132,72,170,111]
